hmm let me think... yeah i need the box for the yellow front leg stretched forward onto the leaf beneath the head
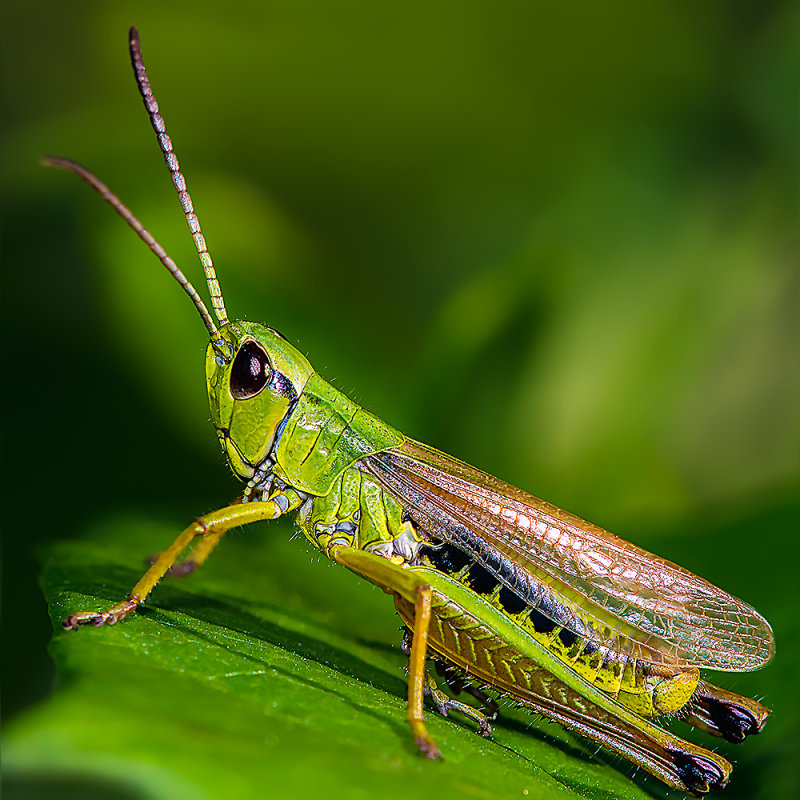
[61,500,287,630]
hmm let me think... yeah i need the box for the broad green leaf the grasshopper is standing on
[4,519,663,800]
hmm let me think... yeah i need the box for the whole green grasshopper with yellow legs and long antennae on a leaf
[45,28,774,796]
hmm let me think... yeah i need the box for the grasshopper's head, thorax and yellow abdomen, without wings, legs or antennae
[206,321,698,717]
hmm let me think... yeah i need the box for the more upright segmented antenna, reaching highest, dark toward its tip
[128,28,228,327]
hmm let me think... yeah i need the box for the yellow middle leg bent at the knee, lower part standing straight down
[328,545,442,758]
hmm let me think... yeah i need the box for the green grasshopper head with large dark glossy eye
[206,320,314,480]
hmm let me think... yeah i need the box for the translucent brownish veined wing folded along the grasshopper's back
[366,439,774,671]
